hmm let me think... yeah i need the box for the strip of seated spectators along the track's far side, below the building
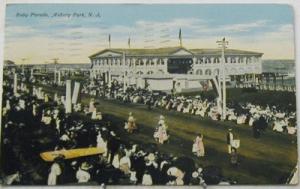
[82,75,297,136]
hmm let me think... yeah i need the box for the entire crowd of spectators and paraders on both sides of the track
[2,68,296,185]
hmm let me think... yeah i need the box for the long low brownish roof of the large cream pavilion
[89,47,263,58]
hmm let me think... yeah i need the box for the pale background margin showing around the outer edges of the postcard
[0,0,300,189]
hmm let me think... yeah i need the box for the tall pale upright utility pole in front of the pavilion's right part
[217,37,228,120]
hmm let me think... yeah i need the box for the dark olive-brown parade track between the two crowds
[34,84,297,184]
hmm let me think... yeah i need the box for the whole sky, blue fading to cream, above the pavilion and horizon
[4,4,294,64]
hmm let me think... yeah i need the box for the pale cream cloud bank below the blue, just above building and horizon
[5,18,294,63]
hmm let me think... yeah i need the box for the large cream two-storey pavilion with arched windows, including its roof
[89,47,263,91]
